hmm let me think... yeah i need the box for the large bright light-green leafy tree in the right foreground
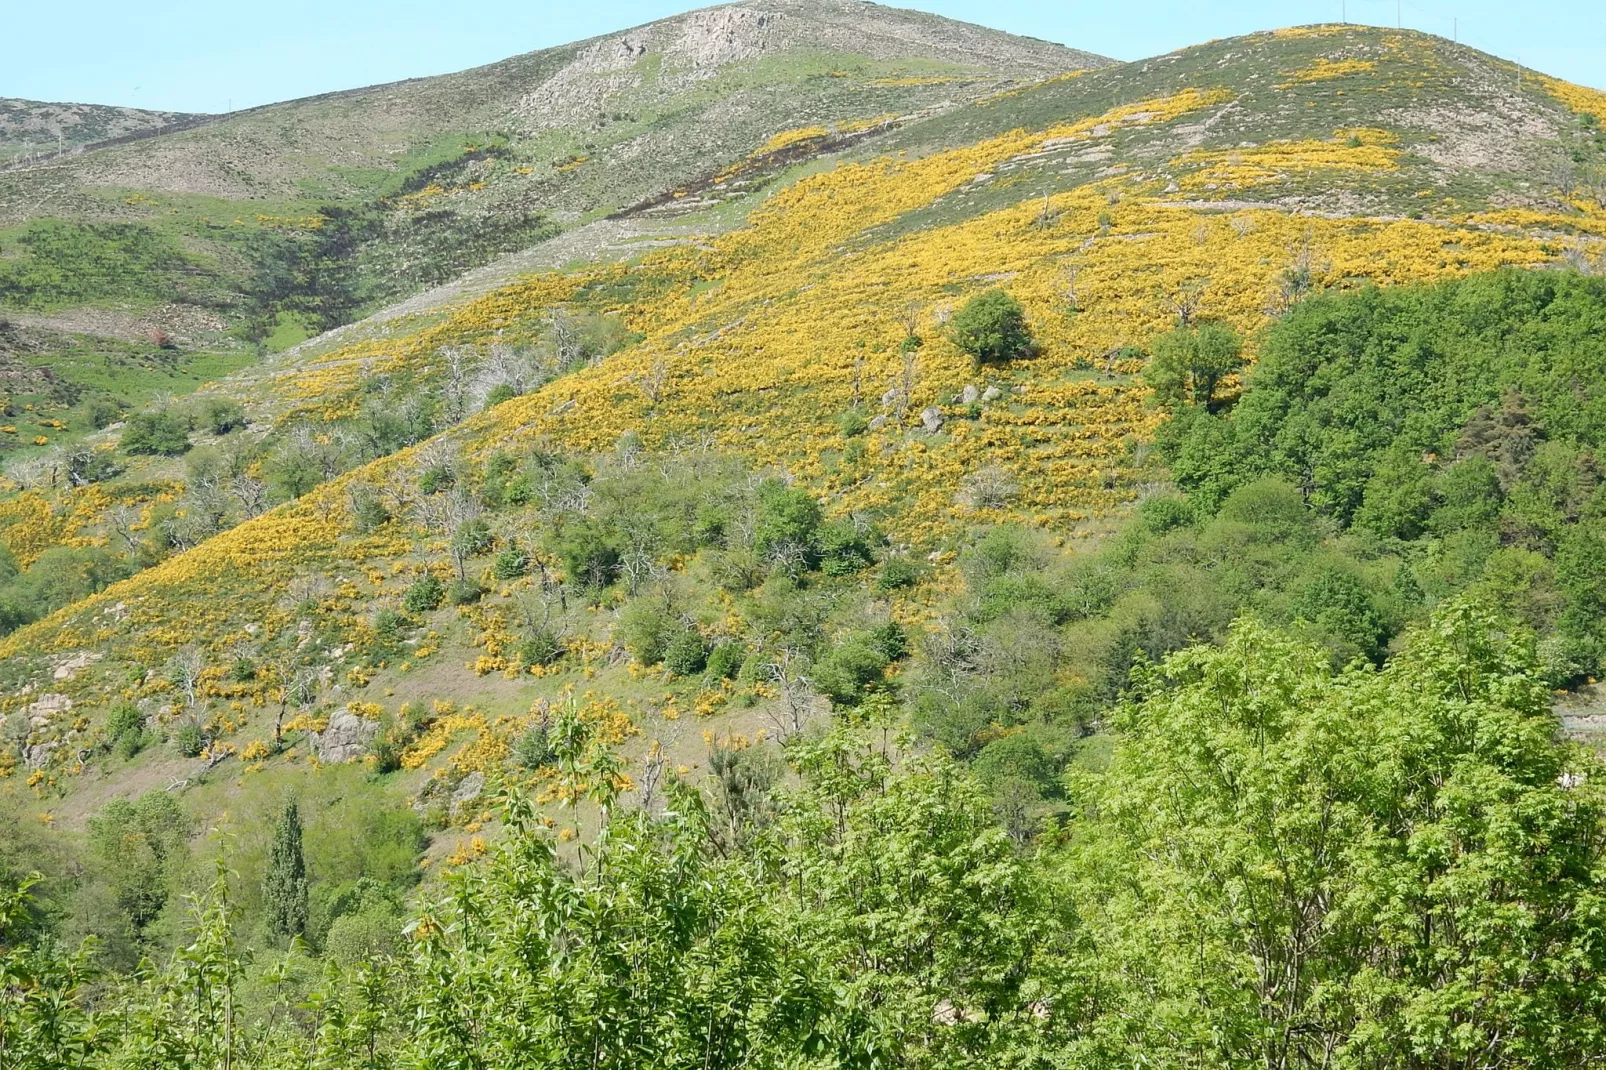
[1070,602,1606,1067]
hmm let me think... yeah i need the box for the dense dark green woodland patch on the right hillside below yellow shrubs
[1160,272,1606,684]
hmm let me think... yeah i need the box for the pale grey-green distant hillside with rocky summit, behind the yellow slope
[0,0,1108,458]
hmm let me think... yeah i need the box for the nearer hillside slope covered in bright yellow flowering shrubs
[0,27,1603,809]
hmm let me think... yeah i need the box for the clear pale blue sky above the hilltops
[0,0,1606,111]
